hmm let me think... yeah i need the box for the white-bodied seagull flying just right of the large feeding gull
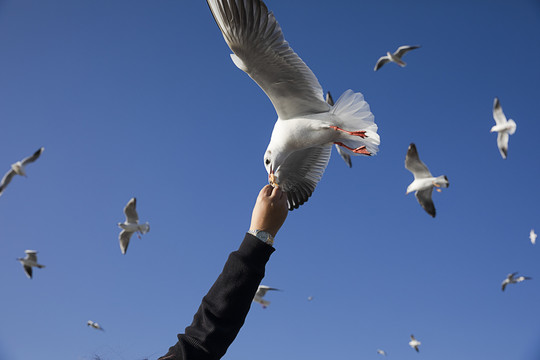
[405,143,450,217]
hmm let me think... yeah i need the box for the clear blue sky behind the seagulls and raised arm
[0,0,540,360]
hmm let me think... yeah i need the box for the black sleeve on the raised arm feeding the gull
[158,234,274,360]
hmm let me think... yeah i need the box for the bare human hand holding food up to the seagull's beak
[249,185,289,236]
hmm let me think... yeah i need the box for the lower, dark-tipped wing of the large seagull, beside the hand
[279,145,332,210]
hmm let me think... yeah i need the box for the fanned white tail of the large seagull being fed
[331,90,381,155]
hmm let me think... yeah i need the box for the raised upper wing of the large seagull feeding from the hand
[207,0,329,120]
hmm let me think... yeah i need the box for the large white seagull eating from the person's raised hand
[207,0,380,210]
